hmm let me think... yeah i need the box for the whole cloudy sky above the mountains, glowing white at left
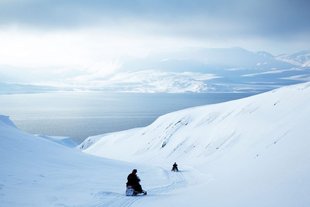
[0,0,310,85]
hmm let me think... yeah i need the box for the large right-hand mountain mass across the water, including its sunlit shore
[90,48,310,93]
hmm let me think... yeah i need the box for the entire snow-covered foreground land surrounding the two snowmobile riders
[0,83,310,207]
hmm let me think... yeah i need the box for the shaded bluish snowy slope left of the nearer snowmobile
[0,115,170,207]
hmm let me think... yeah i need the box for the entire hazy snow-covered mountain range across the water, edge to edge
[0,48,310,93]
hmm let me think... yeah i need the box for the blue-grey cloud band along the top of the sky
[0,0,310,41]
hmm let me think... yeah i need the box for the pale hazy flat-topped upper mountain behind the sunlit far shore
[122,47,292,72]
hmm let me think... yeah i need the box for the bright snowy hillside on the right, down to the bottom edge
[80,83,310,207]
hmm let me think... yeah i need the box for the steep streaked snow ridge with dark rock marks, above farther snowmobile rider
[82,83,310,164]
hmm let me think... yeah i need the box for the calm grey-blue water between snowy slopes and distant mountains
[0,92,253,142]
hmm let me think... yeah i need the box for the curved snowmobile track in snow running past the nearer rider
[91,171,187,207]
